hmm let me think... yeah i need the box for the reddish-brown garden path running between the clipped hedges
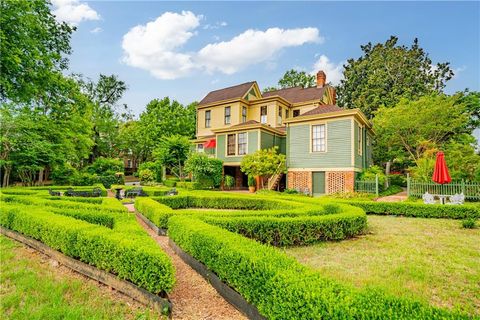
[125,204,247,320]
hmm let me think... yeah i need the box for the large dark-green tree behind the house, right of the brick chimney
[337,36,453,118]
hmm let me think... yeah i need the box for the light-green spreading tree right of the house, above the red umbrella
[373,94,471,170]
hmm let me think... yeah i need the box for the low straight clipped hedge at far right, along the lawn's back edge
[342,200,480,219]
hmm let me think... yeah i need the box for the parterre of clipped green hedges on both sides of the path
[0,188,479,319]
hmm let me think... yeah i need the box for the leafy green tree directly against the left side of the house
[139,97,197,158]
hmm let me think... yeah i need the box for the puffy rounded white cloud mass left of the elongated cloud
[122,11,202,79]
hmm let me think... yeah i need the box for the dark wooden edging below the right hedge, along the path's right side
[168,239,266,320]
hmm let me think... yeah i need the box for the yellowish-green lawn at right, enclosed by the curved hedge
[286,216,480,316]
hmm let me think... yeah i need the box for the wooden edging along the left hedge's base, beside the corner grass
[0,226,172,315]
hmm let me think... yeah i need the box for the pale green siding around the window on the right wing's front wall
[287,119,352,168]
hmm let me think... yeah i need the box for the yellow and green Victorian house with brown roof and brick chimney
[194,71,373,194]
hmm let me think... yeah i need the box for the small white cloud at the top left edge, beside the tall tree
[52,0,100,25]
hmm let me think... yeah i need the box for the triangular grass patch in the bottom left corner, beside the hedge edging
[0,236,163,319]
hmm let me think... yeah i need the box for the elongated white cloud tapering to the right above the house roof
[198,28,322,74]
